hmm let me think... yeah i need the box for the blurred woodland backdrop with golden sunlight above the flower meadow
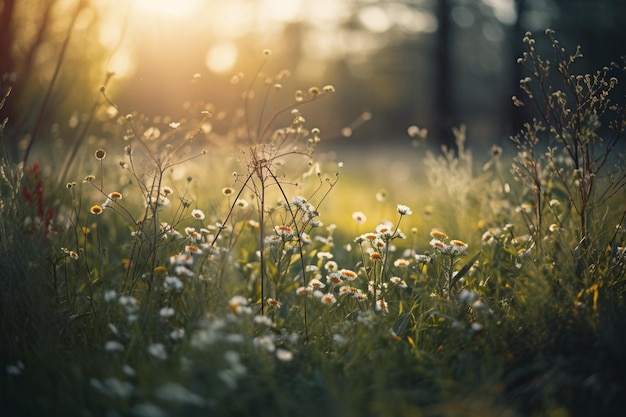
[0,0,626,171]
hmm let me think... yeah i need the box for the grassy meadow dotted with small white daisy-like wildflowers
[0,30,626,417]
